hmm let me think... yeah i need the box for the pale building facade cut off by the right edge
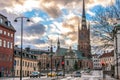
[114,23,120,79]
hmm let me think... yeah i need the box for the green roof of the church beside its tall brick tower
[56,48,87,60]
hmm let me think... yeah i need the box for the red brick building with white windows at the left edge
[0,14,15,77]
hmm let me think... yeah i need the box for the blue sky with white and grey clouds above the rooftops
[0,0,115,50]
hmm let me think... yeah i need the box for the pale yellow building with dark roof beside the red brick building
[14,47,38,76]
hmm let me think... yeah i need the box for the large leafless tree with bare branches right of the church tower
[91,1,120,50]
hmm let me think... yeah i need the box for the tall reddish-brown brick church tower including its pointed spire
[78,0,91,58]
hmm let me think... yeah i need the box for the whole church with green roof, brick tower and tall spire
[54,0,92,71]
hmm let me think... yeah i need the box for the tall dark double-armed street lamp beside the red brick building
[14,17,30,80]
